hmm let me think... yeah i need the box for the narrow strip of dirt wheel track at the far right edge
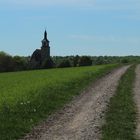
[134,65,140,138]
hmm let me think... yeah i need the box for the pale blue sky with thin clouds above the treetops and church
[0,0,140,56]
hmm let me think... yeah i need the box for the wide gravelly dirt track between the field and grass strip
[24,66,128,140]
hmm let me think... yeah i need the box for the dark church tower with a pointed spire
[41,30,50,61]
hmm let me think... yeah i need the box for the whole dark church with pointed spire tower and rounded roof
[30,30,50,69]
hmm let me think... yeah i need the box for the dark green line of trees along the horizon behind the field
[0,52,140,72]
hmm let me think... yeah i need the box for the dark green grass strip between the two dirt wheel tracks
[102,66,136,140]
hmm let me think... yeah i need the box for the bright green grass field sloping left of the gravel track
[0,64,118,140]
